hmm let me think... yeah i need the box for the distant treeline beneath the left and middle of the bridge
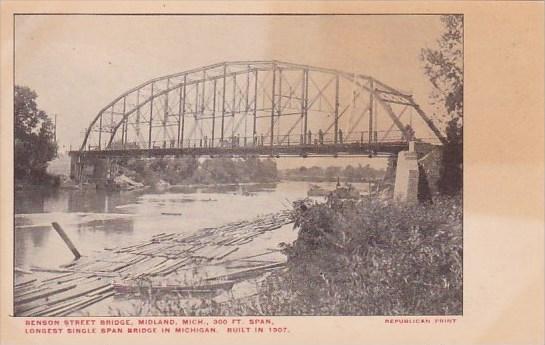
[119,157,278,185]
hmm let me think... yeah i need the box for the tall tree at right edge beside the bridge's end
[421,15,464,195]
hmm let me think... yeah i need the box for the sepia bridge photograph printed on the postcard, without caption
[13,13,464,316]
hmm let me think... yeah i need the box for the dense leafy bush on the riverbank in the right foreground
[255,194,463,315]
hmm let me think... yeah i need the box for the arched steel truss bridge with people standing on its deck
[73,60,444,158]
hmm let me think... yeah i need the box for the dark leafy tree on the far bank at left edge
[14,86,57,184]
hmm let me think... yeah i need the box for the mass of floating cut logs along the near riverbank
[14,211,292,316]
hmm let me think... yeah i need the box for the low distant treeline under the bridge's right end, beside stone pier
[281,164,385,182]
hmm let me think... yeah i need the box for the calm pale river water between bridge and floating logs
[15,182,365,268]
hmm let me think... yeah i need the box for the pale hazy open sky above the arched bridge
[15,15,441,169]
